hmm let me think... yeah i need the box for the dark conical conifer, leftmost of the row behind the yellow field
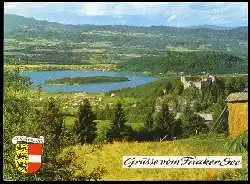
[74,99,96,144]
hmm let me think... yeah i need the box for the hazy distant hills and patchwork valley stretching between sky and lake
[4,14,248,72]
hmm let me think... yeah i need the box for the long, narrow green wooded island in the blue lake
[45,76,129,85]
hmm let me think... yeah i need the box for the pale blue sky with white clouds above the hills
[4,2,248,27]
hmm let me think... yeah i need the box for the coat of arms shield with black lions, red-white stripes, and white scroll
[12,136,44,174]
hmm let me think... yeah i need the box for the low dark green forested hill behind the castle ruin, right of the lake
[120,51,248,74]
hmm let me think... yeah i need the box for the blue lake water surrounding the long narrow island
[20,70,158,92]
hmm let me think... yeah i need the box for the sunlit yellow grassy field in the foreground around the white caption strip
[59,135,248,180]
